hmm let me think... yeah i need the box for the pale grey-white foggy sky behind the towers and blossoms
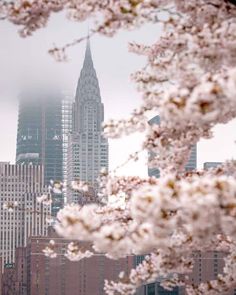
[0,14,236,175]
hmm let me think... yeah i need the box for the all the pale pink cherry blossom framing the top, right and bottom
[0,0,236,295]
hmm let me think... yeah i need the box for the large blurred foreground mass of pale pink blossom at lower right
[53,173,236,294]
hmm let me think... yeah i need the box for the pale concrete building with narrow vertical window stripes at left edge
[0,162,51,269]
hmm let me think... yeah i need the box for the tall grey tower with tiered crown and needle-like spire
[67,38,108,203]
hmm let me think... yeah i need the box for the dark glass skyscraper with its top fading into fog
[16,90,63,215]
